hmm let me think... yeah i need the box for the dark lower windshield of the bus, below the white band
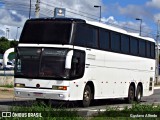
[15,48,68,79]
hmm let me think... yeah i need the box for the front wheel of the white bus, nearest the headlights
[82,85,92,107]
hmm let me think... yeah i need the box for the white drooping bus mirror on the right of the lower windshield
[65,50,73,69]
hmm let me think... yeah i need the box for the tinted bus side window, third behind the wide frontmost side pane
[121,35,129,53]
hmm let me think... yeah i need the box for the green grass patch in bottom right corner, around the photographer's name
[91,104,160,120]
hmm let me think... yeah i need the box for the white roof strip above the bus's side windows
[86,21,155,42]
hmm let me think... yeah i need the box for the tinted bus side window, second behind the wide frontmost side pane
[111,32,120,52]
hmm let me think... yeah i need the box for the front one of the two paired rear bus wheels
[127,85,135,103]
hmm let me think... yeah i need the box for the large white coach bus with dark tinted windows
[14,18,155,107]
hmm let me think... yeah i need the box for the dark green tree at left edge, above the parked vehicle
[0,37,10,54]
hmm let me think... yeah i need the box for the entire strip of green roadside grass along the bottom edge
[2,102,160,120]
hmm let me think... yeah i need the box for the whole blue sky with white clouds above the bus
[0,0,160,40]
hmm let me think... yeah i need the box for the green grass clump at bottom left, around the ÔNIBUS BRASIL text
[5,102,84,120]
